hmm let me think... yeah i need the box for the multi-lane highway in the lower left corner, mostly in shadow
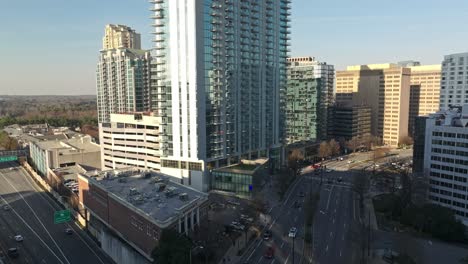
[0,163,113,264]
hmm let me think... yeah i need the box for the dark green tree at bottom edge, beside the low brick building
[151,229,192,264]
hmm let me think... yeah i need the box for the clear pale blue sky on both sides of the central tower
[0,0,468,95]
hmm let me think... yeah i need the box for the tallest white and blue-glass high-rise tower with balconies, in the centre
[151,0,291,190]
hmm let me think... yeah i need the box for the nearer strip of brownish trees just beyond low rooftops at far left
[0,116,97,128]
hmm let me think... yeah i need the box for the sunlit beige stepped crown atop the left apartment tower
[102,24,141,50]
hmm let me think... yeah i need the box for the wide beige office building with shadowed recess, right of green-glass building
[336,64,411,146]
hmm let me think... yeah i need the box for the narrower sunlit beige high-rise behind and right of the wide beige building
[408,64,441,135]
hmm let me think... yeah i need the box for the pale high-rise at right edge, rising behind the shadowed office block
[440,52,468,109]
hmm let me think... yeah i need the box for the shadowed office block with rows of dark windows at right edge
[424,105,468,225]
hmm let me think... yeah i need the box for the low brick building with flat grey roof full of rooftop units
[78,168,208,263]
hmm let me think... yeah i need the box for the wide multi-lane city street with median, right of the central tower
[244,150,411,264]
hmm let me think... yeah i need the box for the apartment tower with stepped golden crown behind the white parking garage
[96,25,151,123]
